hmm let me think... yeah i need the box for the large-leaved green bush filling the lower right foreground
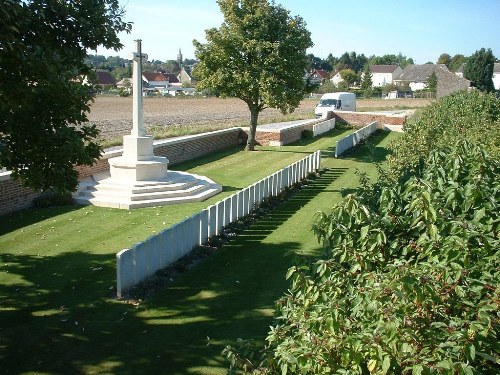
[225,142,500,374]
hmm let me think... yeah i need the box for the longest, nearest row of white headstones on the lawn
[116,151,321,298]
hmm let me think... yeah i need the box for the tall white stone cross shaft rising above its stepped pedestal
[129,39,148,137]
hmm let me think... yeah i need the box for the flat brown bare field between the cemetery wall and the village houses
[88,96,429,139]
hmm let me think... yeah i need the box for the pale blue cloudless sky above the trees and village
[97,0,500,64]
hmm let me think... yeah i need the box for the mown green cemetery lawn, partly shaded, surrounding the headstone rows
[0,130,397,374]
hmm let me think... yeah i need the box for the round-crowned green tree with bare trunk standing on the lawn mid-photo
[193,0,313,151]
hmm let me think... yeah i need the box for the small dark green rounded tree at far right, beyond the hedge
[464,48,495,92]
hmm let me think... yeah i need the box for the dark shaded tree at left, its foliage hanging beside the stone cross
[0,0,131,192]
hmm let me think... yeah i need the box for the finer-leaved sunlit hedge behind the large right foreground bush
[388,90,500,178]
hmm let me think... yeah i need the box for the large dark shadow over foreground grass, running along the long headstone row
[0,164,344,374]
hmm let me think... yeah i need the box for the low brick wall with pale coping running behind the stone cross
[0,128,247,215]
